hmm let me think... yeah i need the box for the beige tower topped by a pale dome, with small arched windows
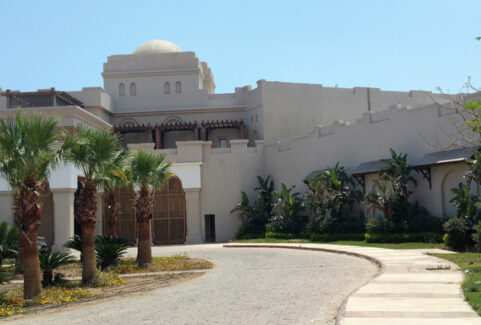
[102,40,215,112]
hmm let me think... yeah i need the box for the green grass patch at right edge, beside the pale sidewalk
[431,253,481,315]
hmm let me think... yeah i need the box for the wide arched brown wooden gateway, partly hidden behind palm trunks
[103,176,186,245]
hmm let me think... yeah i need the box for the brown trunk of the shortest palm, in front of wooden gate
[135,188,152,267]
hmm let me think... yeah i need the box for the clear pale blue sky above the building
[0,0,481,93]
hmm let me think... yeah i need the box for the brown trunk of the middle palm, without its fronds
[75,181,97,284]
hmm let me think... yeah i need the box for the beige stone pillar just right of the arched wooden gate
[185,188,202,244]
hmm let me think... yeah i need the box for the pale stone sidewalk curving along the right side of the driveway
[226,244,481,325]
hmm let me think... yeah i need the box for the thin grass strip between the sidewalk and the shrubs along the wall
[235,238,444,249]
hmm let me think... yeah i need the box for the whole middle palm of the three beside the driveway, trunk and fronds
[63,126,124,283]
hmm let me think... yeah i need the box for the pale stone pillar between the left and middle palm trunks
[51,188,76,251]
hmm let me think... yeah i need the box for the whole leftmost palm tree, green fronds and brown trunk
[0,112,60,299]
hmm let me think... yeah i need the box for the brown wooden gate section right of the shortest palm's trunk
[152,176,187,245]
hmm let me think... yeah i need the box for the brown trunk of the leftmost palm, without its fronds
[15,177,42,299]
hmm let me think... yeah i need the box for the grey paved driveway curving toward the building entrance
[5,244,377,325]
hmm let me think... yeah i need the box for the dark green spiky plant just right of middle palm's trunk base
[95,236,129,270]
